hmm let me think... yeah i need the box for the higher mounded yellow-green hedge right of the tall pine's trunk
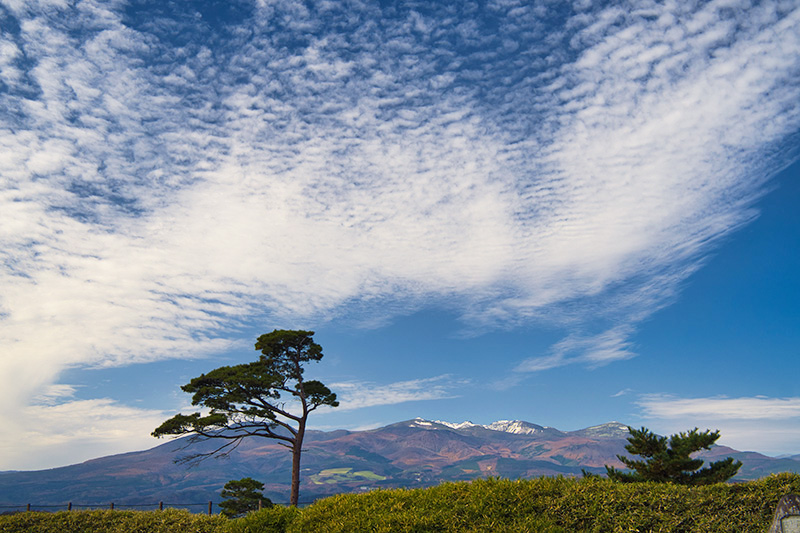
[287,474,800,533]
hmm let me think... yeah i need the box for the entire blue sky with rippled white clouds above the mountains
[0,0,800,470]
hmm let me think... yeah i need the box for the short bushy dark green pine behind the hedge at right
[606,427,742,485]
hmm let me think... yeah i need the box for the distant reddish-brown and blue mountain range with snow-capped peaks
[0,418,800,511]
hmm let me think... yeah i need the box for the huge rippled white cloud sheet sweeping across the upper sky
[0,2,800,466]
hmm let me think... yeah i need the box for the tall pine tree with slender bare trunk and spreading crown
[153,329,339,505]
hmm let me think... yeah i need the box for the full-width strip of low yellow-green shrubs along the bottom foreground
[0,474,800,533]
